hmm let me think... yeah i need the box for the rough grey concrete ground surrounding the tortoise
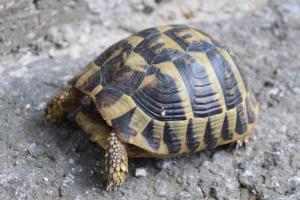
[0,0,300,200]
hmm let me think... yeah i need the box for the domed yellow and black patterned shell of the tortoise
[74,25,258,155]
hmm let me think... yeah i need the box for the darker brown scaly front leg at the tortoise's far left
[45,87,81,122]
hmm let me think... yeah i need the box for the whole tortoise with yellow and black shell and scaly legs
[45,25,259,190]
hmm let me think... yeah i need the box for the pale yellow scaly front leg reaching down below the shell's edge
[105,133,128,191]
